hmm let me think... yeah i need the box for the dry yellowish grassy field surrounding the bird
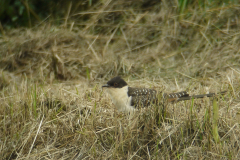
[0,0,240,160]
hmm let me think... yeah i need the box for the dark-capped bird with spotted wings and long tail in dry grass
[102,76,226,112]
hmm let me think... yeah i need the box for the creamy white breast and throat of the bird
[106,86,134,112]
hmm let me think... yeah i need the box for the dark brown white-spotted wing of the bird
[128,87,157,108]
